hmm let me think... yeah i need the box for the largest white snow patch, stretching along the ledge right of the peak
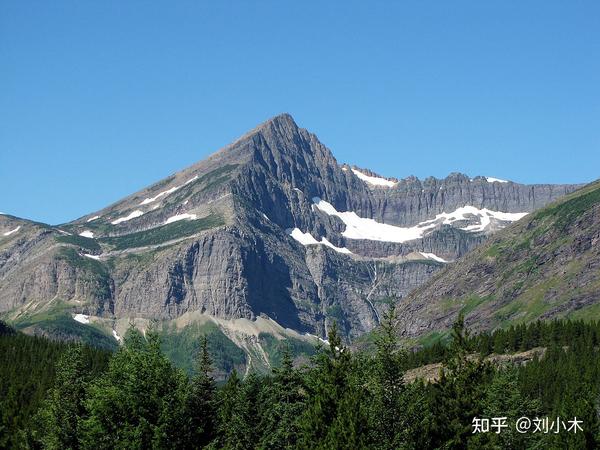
[312,197,527,243]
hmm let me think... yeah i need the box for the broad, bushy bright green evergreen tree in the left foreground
[81,330,187,449]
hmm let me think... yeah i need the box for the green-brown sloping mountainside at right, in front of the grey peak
[399,182,600,339]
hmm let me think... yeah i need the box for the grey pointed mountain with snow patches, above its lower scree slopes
[0,114,577,338]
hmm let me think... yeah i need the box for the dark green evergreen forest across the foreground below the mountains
[3,309,600,449]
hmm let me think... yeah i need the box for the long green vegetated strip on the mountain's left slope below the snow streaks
[101,214,225,250]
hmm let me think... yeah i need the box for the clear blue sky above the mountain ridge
[0,0,600,223]
